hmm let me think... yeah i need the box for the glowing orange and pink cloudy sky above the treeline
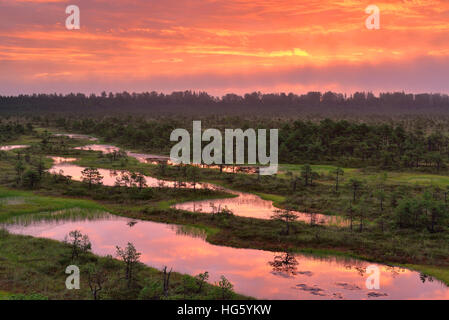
[0,0,449,95]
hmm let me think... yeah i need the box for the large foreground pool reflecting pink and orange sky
[4,217,449,299]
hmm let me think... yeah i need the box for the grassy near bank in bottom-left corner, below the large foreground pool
[0,229,248,300]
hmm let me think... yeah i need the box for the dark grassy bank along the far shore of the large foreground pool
[106,205,449,281]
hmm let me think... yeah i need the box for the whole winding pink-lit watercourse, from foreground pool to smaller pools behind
[0,138,449,299]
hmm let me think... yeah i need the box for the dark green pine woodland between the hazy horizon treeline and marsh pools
[12,116,449,172]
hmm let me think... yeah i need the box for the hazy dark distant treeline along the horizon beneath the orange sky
[0,91,449,115]
